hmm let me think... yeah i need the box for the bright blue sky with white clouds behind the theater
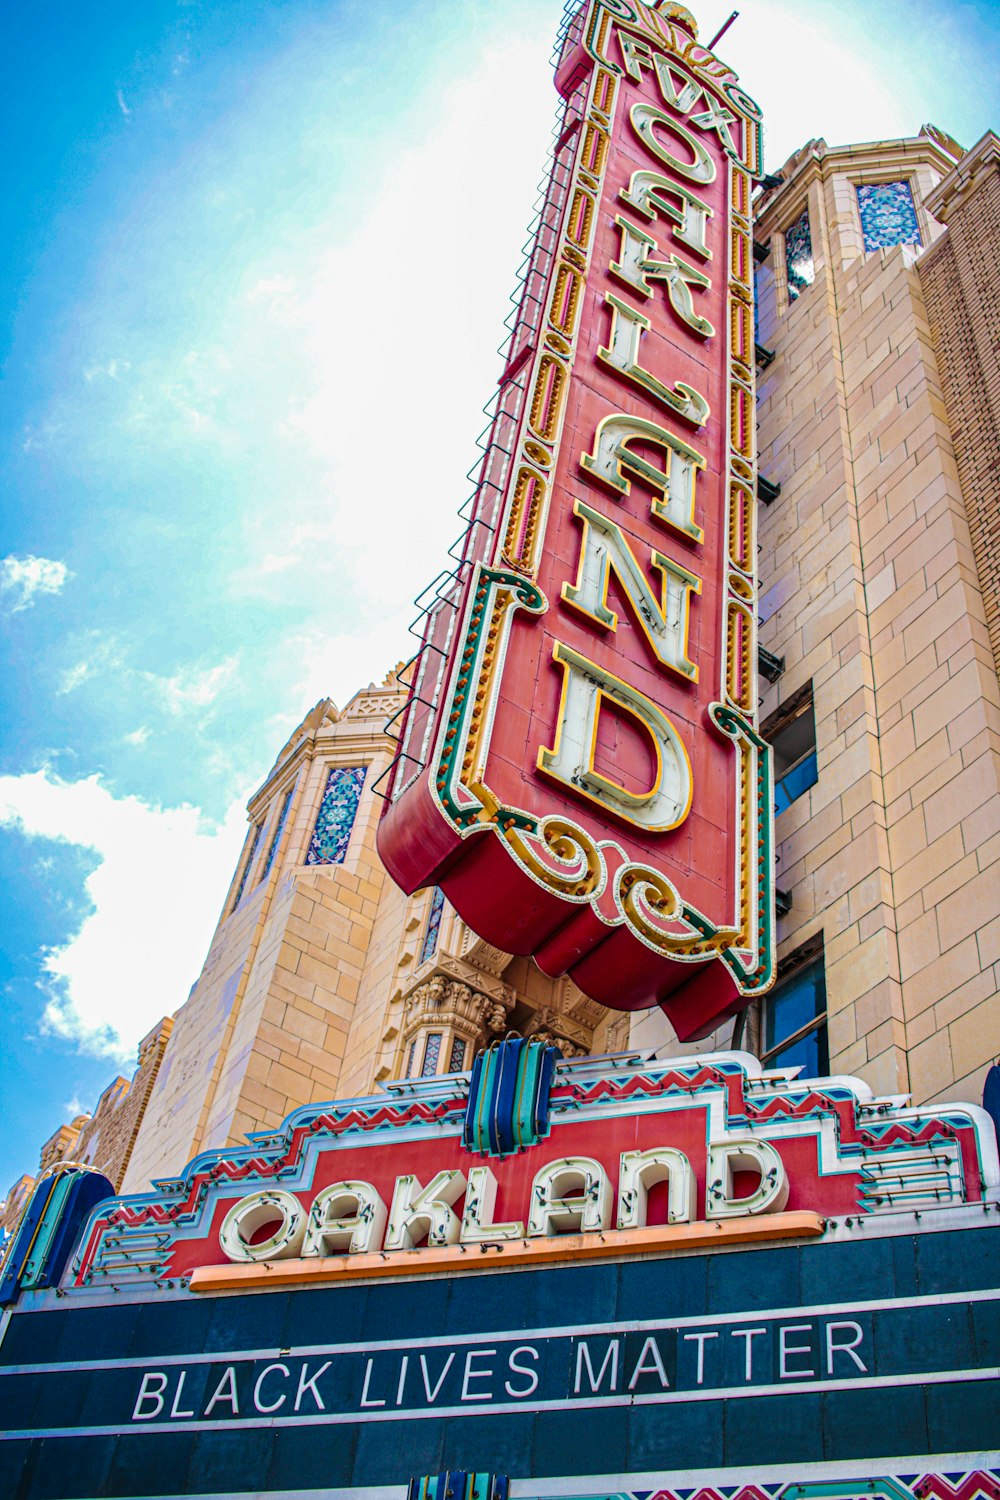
[0,0,1000,1193]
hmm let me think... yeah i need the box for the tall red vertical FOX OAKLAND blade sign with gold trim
[379,0,774,1038]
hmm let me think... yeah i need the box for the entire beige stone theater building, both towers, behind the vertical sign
[7,126,1000,1203]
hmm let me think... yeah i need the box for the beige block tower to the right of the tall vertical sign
[757,132,1000,1101]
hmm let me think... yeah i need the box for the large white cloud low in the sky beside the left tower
[0,768,246,1062]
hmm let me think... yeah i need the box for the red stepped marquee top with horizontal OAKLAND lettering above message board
[56,1041,1000,1292]
